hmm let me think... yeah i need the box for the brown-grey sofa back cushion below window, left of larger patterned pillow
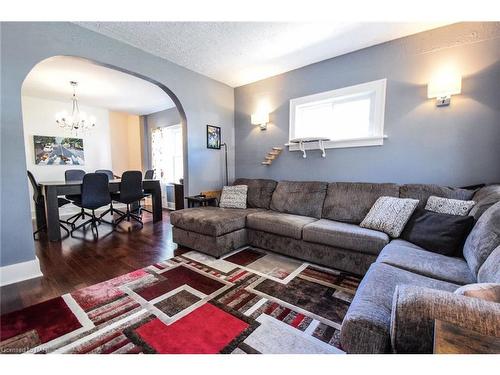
[322,182,399,224]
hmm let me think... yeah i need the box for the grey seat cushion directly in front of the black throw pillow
[377,242,476,285]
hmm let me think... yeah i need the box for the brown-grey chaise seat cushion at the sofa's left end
[170,207,258,237]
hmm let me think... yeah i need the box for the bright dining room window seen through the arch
[151,125,184,184]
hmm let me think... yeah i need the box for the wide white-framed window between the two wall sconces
[289,79,386,151]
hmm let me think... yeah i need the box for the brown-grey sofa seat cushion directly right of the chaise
[247,211,316,240]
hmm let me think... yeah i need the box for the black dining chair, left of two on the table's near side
[71,173,111,238]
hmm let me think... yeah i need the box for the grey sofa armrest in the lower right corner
[391,285,500,353]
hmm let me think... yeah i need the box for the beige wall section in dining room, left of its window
[109,111,142,175]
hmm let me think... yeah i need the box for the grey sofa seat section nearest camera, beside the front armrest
[340,263,459,353]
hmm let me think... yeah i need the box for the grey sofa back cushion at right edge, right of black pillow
[464,202,500,277]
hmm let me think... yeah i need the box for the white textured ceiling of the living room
[78,22,446,87]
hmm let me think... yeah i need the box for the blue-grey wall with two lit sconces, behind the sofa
[235,23,500,186]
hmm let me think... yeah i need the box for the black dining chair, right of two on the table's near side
[111,171,144,227]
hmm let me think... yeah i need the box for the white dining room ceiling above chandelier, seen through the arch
[22,56,175,115]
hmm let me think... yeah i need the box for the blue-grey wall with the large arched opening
[0,22,234,266]
